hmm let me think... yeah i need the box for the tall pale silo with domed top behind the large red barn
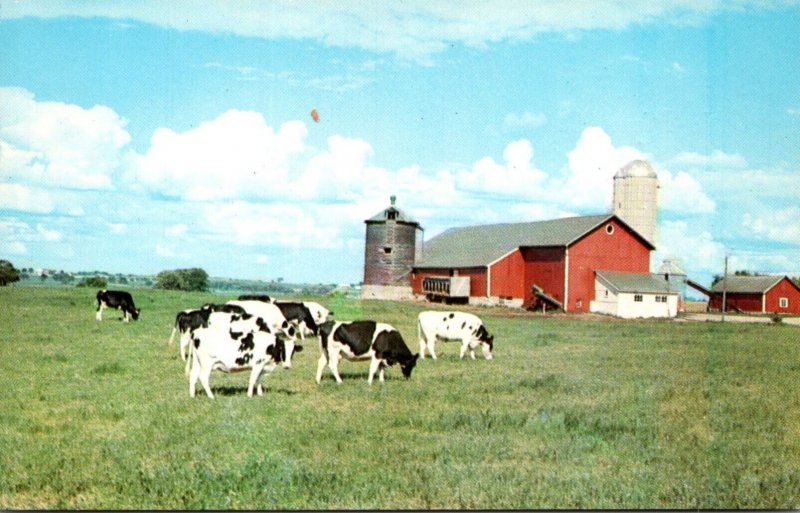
[613,160,658,244]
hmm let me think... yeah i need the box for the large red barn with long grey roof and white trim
[411,214,655,312]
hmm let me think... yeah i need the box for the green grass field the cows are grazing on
[0,287,800,509]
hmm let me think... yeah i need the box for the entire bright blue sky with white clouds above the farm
[0,0,800,285]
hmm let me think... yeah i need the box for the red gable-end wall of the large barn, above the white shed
[567,219,650,312]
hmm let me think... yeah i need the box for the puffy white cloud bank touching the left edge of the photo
[0,87,130,189]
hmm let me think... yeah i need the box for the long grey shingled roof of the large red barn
[414,214,652,268]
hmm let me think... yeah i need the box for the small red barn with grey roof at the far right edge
[708,276,800,314]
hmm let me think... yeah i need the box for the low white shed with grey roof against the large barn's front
[590,271,680,319]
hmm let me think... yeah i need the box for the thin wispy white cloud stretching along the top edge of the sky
[0,0,790,61]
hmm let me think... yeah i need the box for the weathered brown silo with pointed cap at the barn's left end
[361,196,422,299]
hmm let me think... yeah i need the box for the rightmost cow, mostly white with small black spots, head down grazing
[417,311,494,360]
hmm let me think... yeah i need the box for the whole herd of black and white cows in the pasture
[96,290,494,399]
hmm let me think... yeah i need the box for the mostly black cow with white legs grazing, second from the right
[317,321,419,385]
